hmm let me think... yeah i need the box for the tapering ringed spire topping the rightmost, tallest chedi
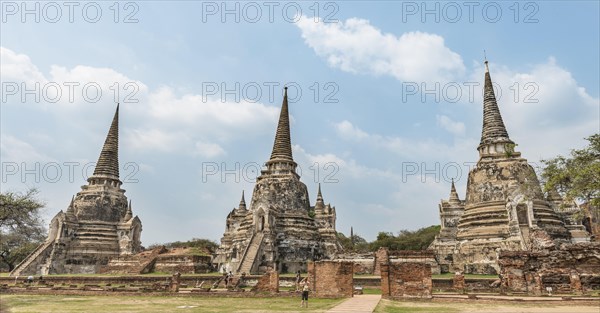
[479,60,514,153]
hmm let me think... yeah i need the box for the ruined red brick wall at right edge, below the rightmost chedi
[499,243,600,295]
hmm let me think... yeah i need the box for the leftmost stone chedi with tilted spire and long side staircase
[11,106,142,276]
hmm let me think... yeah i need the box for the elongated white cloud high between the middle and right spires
[296,16,465,82]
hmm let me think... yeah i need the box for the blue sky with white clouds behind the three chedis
[0,1,600,245]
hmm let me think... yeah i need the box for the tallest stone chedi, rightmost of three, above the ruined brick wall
[430,61,571,273]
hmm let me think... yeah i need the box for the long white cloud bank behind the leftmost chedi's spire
[0,47,279,157]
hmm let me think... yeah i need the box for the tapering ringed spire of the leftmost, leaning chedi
[94,104,119,180]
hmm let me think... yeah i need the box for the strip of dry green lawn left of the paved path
[0,295,344,313]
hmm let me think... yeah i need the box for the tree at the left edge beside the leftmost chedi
[0,188,46,271]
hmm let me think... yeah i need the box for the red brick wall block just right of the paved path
[380,262,432,299]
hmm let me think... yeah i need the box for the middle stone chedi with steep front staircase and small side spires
[213,87,341,273]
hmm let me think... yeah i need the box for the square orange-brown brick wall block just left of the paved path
[308,261,354,298]
